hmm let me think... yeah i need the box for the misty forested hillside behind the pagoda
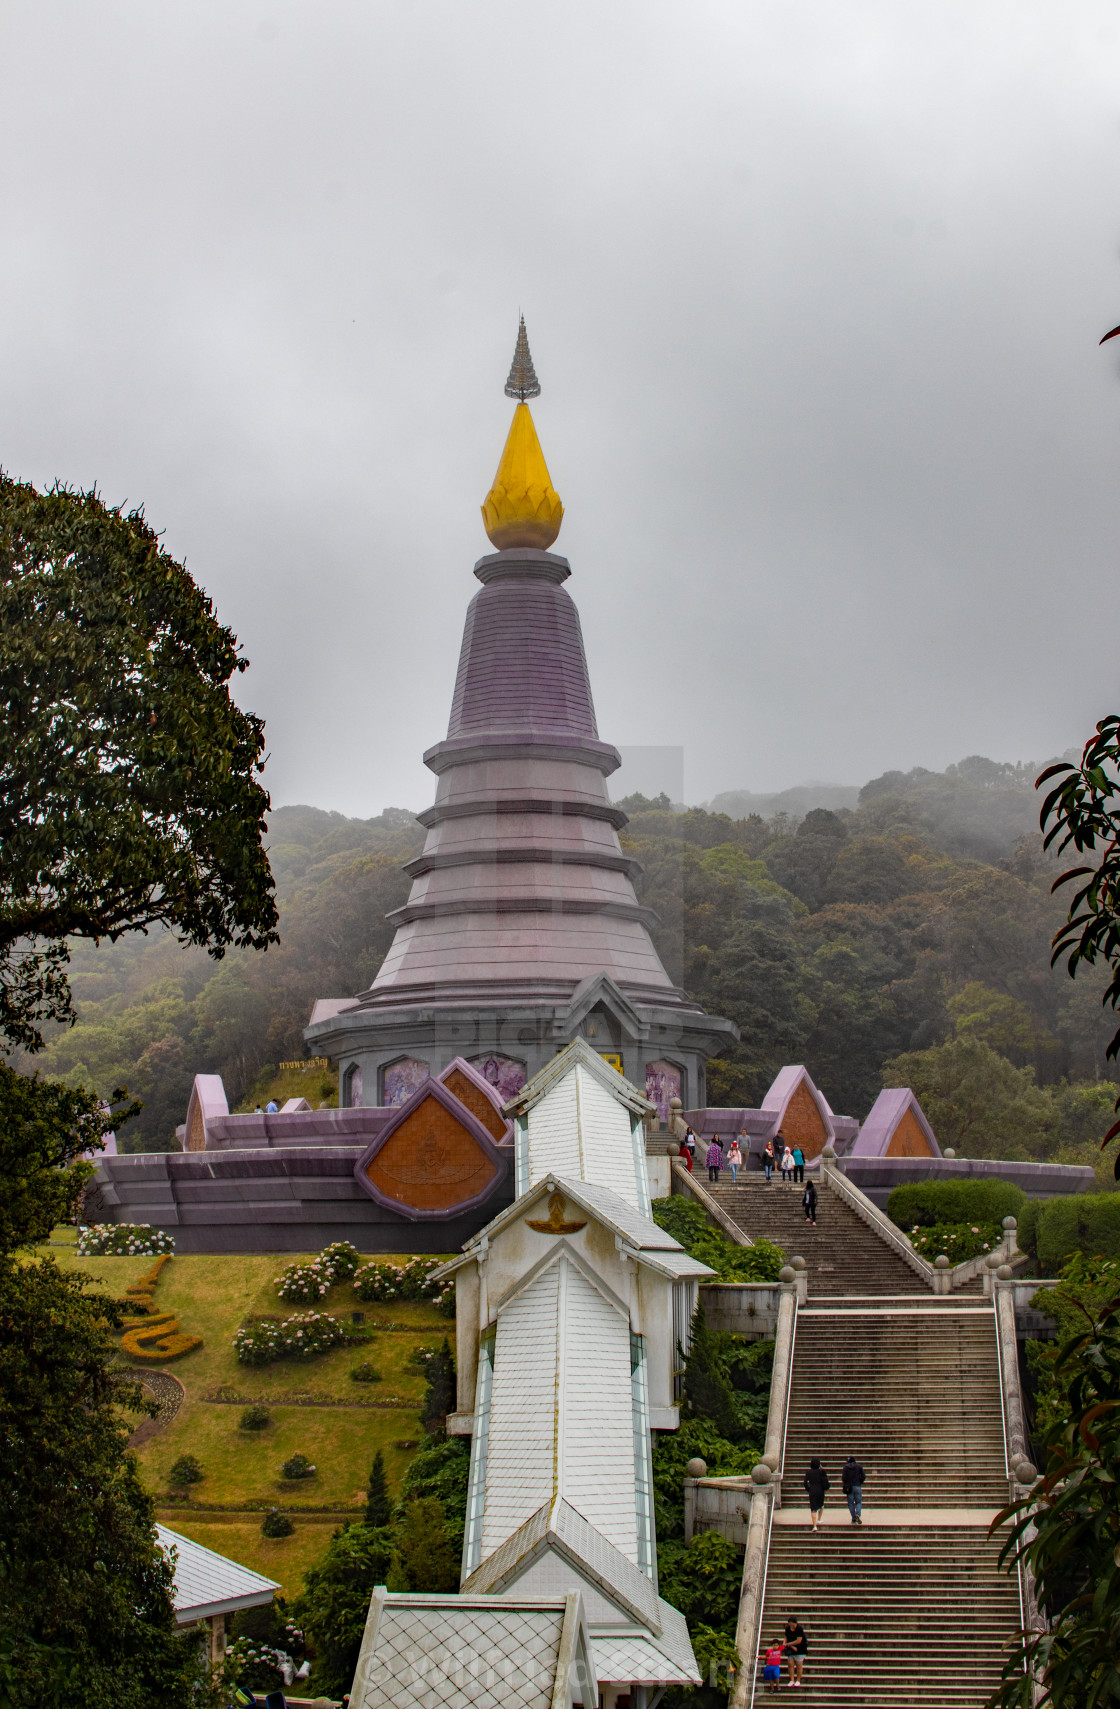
[35,757,1117,1181]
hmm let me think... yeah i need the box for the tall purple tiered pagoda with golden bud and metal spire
[306,320,737,1116]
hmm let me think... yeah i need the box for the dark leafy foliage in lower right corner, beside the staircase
[992,1266,1120,1709]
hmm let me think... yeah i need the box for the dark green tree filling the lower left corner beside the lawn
[0,1256,209,1709]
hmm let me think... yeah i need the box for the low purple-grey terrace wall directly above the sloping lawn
[89,1145,513,1253]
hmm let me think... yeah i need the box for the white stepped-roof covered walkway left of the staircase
[352,1039,711,1709]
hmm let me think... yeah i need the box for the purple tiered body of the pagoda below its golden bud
[359,547,694,1008]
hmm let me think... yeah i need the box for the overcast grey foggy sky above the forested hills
[0,0,1120,815]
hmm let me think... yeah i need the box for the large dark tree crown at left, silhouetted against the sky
[0,473,275,1049]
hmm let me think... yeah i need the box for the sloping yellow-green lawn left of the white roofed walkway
[36,1229,455,1594]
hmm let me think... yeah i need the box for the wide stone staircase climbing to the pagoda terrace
[718,1176,1021,1709]
